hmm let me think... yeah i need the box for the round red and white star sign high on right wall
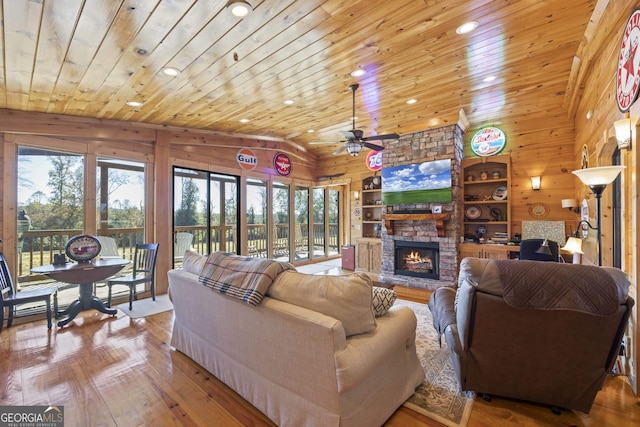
[616,9,640,113]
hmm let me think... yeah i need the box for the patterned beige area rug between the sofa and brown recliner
[395,300,475,427]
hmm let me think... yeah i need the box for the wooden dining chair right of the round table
[107,243,158,310]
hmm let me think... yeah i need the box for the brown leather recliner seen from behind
[429,258,634,413]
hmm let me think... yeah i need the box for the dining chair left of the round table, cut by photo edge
[0,253,58,332]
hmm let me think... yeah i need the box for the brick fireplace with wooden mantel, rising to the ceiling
[379,125,463,290]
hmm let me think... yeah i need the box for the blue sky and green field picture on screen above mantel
[382,159,452,205]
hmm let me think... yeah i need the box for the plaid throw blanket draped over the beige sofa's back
[199,252,295,305]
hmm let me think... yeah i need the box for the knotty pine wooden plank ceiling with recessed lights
[0,0,596,158]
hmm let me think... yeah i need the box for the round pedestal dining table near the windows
[31,259,131,327]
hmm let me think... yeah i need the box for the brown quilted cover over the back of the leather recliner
[494,260,619,316]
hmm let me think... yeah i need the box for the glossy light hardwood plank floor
[0,276,640,427]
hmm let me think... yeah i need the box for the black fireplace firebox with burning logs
[394,240,440,280]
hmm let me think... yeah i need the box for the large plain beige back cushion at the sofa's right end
[268,271,376,336]
